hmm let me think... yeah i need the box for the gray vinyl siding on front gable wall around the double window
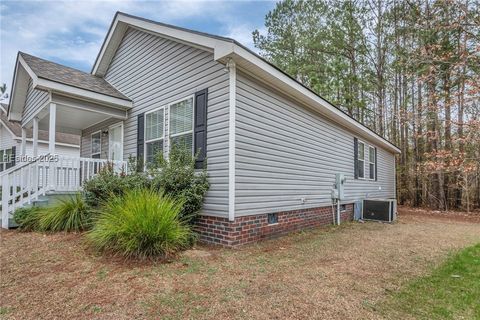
[105,28,229,216]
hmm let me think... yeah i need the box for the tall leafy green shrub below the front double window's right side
[150,144,210,222]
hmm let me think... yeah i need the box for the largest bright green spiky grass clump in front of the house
[87,189,193,258]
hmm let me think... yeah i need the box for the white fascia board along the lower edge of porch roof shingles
[36,78,133,109]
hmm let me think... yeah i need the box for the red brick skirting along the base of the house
[195,204,353,247]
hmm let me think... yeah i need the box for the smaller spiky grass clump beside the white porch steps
[37,194,92,231]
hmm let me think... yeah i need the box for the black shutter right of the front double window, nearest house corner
[193,89,208,169]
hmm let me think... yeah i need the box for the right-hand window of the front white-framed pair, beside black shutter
[169,97,193,154]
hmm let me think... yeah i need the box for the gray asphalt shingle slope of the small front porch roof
[20,52,130,101]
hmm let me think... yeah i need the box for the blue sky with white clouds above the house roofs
[0,0,275,95]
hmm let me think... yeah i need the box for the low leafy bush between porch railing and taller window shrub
[83,165,149,207]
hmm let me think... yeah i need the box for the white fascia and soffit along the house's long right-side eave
[215,44,401,153]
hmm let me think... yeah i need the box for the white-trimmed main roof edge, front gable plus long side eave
[92,12,401,153]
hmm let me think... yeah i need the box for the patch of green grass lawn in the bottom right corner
[377,243,480,319]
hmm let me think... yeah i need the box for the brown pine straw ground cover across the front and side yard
[0,208,480,319]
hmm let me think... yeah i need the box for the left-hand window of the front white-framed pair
[145,107,165,163]
